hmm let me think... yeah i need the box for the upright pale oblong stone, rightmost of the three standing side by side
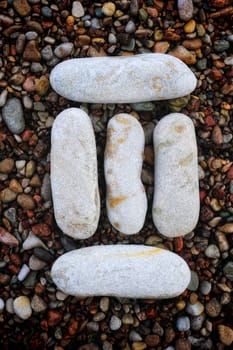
[152,113,200,237]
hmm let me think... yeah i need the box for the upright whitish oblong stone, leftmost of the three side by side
[51,108,100,239]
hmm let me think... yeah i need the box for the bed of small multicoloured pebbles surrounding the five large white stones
[0,0,233,350]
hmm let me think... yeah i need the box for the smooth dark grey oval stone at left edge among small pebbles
[2,97,25,134]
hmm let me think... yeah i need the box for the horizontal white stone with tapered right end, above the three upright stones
[50,53,197,103]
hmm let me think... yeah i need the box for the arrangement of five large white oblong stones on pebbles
[51,54,199,299]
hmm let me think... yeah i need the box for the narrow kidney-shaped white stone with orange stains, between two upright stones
[104,113,147,234]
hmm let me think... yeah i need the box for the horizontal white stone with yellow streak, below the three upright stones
[51,244,190,299]
